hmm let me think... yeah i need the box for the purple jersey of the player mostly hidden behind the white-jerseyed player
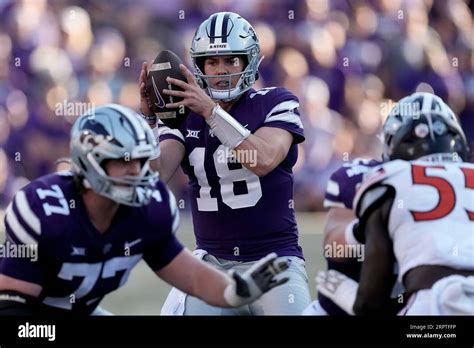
[318,158,382,315]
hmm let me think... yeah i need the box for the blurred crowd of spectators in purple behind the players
[0,0,474,210]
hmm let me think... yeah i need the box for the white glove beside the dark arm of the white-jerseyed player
[316,269,359,315]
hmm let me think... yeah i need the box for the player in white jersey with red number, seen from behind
[312,92,474,315]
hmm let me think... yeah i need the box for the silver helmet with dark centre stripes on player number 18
[190,12,263,101]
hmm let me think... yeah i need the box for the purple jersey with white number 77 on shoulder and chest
[0,172,183,314]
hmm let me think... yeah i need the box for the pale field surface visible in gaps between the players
[0,212,325,315]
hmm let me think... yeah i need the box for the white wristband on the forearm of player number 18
[206,105,250,150]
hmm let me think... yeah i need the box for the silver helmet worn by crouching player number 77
[71,104,159,207]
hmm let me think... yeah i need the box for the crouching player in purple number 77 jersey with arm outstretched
[0,104,287,315]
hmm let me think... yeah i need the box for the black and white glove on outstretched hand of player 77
[224,253,289,307]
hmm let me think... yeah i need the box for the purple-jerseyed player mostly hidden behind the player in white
[303,92,462,316]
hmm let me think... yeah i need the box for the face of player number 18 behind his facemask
[204,56,244,90]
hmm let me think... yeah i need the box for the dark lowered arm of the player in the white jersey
[354,196,396,315]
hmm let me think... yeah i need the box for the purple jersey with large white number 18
[160,88,304,261]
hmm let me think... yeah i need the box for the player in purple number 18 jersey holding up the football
[140,12,310,315]
